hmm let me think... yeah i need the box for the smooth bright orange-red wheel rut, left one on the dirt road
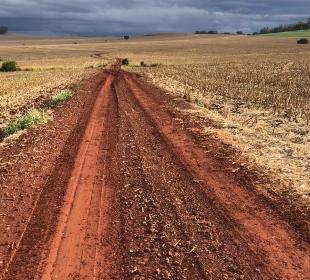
[38,75,115,280]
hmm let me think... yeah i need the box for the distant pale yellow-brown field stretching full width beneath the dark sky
[0,35,310,67]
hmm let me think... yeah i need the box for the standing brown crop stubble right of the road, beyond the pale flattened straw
[145,56,310,124]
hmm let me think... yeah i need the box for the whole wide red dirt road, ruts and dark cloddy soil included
[0,68,310,280]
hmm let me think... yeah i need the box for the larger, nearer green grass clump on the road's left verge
[0,109,50,141]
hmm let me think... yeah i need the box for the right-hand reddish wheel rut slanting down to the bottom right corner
[126,74,310,279]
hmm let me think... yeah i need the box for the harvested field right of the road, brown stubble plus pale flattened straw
[142,55,310,205]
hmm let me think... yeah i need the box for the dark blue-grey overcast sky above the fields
[0,0,310,35]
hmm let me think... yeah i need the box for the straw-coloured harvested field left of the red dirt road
[0,68,95,129]
